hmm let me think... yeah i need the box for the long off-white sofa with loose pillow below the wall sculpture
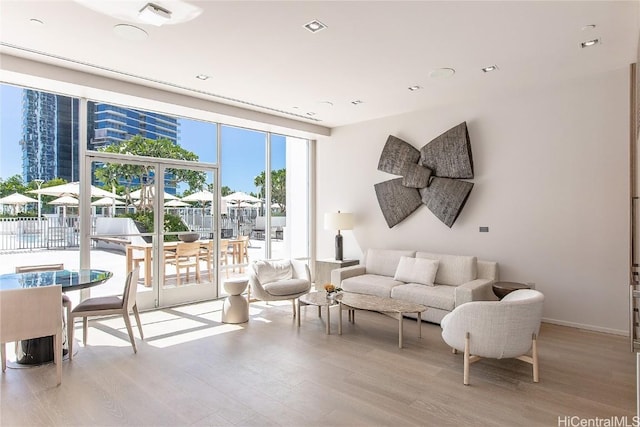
[331,249,498,323]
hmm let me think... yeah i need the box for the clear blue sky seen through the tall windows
[0,85,286,193]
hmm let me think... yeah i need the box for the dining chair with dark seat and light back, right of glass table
[69,268,144,360]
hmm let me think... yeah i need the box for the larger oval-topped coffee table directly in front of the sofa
[338,292,427,348]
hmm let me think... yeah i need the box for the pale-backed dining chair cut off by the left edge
[0,285,63,385]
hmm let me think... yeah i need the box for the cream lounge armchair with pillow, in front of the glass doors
[249,259,311,317]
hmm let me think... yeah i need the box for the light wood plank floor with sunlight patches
[0,301,635,426]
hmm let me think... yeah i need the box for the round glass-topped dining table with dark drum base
[0,268,113,365]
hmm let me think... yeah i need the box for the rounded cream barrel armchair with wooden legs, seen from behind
[440,289,544,385]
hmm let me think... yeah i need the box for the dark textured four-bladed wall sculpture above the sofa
[374,122,473,228]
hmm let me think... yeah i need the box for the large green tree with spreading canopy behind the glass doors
[95,135,206,211]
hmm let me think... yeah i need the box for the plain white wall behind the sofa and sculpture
[317,68,629,334]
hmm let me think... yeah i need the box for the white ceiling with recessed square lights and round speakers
[0,0,640,127]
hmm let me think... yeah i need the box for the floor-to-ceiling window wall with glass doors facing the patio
[0,80,309,306]
